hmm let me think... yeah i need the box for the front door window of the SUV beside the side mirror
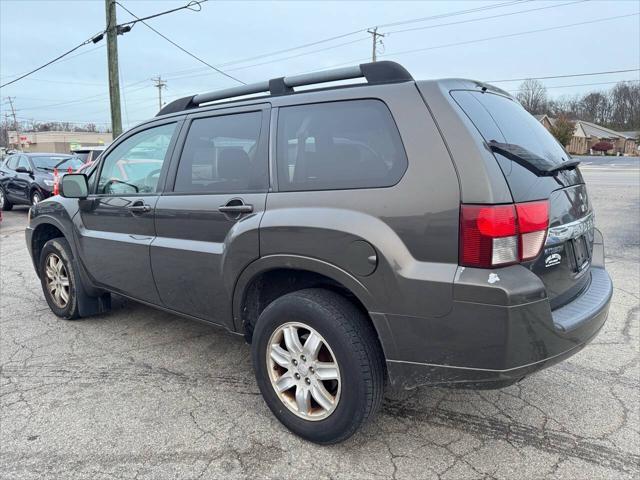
[96,123,176,195]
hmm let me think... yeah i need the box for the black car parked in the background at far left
[0,153,82,210]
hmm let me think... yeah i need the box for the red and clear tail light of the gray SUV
[460,201,549,268]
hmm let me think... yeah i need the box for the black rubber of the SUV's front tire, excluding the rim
[38,237,81,320]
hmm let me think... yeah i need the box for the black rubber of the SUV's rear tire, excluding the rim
[252,289,385,445]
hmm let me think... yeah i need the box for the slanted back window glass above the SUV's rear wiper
[451,90,569,164]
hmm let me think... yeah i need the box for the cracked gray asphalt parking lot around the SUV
[0,159,640,480]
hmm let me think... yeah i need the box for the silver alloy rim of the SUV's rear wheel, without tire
[266,322,341,421]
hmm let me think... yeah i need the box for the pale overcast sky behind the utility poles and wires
[0,0,640,128]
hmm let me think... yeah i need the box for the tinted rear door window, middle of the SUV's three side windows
[174,112,268,193]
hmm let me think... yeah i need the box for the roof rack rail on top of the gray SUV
[156,61,413,116]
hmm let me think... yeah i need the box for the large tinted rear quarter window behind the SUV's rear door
[276,100,407,191]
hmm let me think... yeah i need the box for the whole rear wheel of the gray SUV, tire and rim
[252,289,384,444]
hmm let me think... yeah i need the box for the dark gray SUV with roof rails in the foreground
[26,62,612,444]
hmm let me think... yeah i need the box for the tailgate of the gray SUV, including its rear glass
[451,90,594,309]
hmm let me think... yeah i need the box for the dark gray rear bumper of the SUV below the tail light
[385,229,613,389]
